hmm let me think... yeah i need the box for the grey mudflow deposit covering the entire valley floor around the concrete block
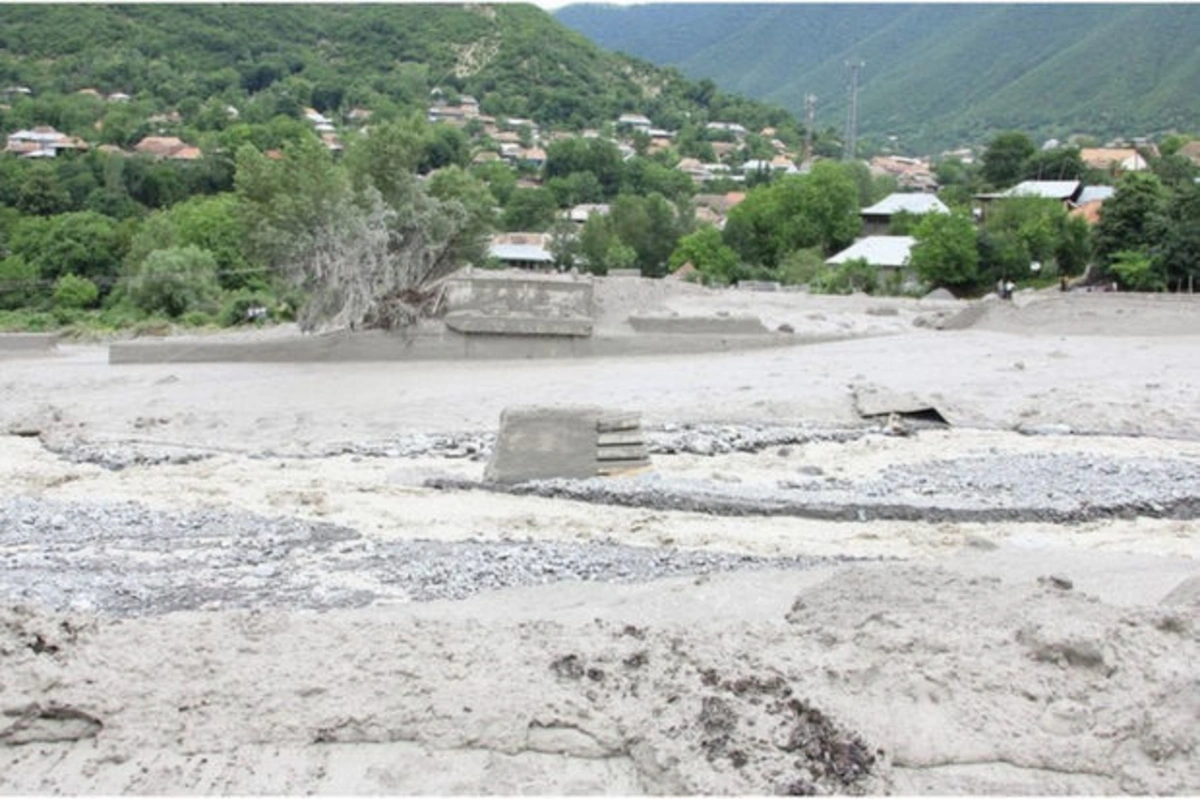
[0,277,1200,794]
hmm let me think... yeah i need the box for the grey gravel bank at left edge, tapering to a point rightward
[0,498,849,615]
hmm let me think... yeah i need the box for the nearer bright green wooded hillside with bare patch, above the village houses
[0,4,796,134]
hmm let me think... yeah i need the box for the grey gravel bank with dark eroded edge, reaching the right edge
[436,452,1200,523]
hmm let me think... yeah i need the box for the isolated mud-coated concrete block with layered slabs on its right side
[484,405,649,483]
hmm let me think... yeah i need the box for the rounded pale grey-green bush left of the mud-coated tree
[127,246,221,318]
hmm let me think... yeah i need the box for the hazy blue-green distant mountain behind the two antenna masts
[557,4,1200,151]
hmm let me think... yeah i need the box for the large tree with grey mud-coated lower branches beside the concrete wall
[235,130,481,330]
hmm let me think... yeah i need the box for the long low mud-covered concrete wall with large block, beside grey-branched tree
[109,269,830,364]
